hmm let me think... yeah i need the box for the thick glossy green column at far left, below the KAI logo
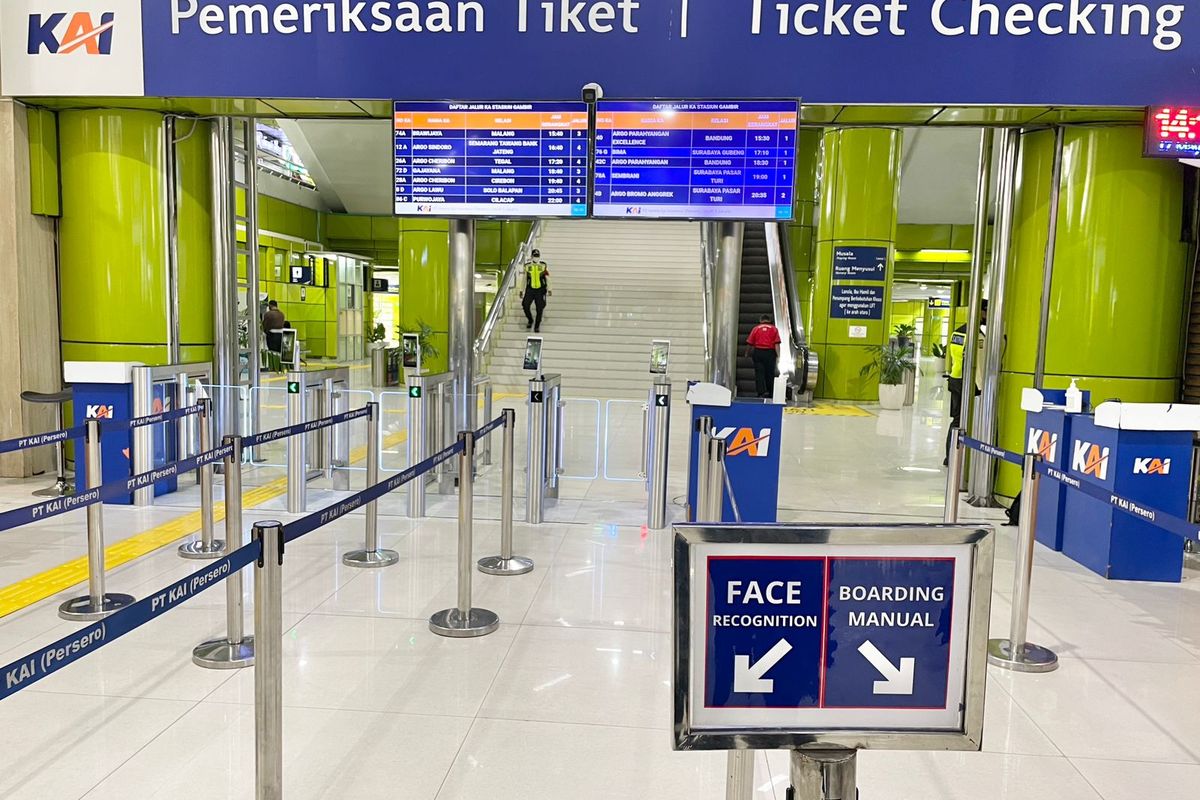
[59,109,212,365]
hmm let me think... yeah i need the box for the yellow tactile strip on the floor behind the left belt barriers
[0,431,408,616]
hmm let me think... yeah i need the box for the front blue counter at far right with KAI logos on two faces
[1060,407,1194,583]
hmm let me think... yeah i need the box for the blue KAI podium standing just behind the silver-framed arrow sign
[688,403,784,522]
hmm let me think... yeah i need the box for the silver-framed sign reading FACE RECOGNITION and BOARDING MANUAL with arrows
[673,525,994,800]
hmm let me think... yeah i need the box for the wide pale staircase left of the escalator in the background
[487,219,704,398]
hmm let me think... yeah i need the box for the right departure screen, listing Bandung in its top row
[593,101,798,219]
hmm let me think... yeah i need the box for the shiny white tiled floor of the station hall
[0,369,1200,800]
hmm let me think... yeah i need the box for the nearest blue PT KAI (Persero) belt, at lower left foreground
[0,542,263,699]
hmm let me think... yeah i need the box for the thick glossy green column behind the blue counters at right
[996,126,1188,497]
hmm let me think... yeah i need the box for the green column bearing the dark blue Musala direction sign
[797,127,904,401]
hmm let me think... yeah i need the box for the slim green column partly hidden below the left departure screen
[400,219,450,372]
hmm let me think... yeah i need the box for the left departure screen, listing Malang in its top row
[394,103,588,217]
